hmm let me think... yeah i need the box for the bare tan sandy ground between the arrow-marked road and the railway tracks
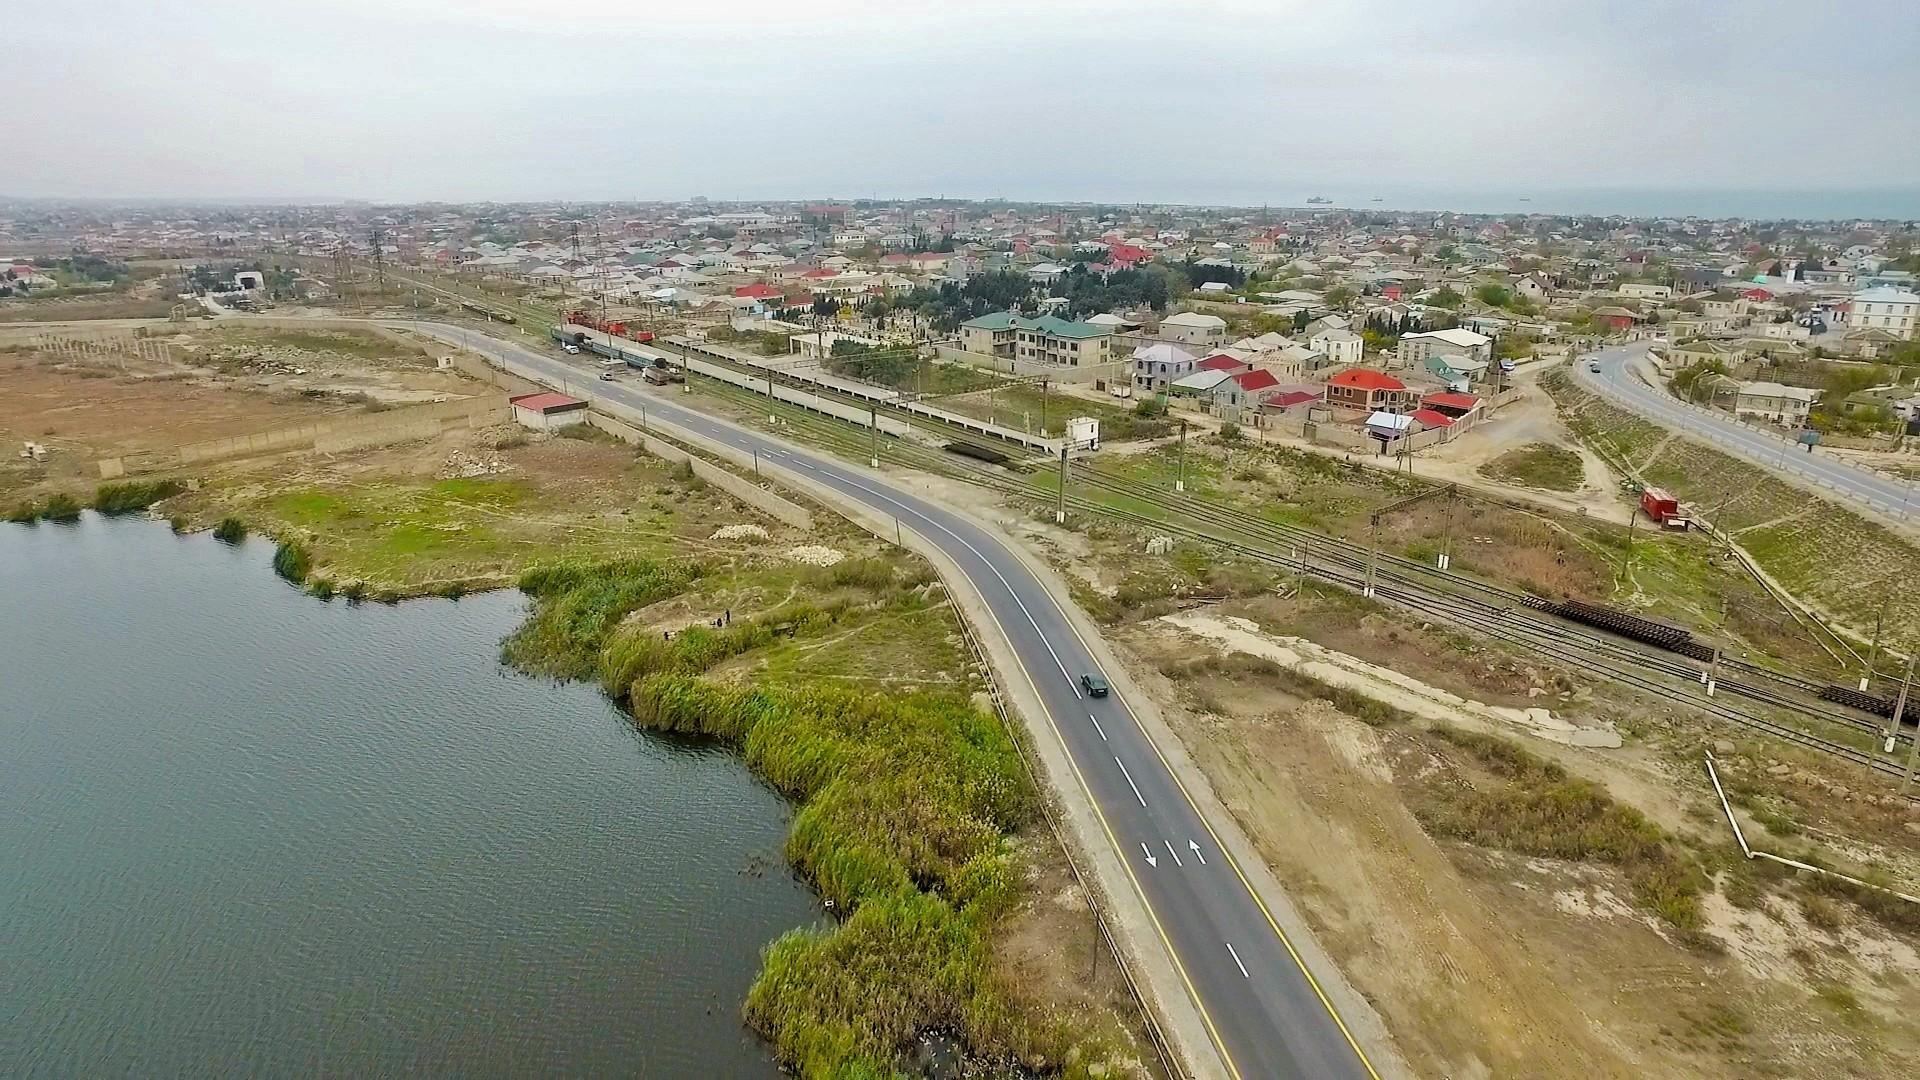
[1117,615,1920,1078]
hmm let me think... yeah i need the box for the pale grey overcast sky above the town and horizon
[11,0,1920,213]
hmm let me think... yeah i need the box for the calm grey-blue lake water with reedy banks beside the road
[0,515,820,1076]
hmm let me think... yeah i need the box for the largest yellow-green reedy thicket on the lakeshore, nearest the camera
[630,675,1033,1076]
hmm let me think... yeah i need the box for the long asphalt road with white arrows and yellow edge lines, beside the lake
[407,323,1373,1080]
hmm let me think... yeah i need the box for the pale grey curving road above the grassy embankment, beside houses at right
[1572,344,1920,521]
